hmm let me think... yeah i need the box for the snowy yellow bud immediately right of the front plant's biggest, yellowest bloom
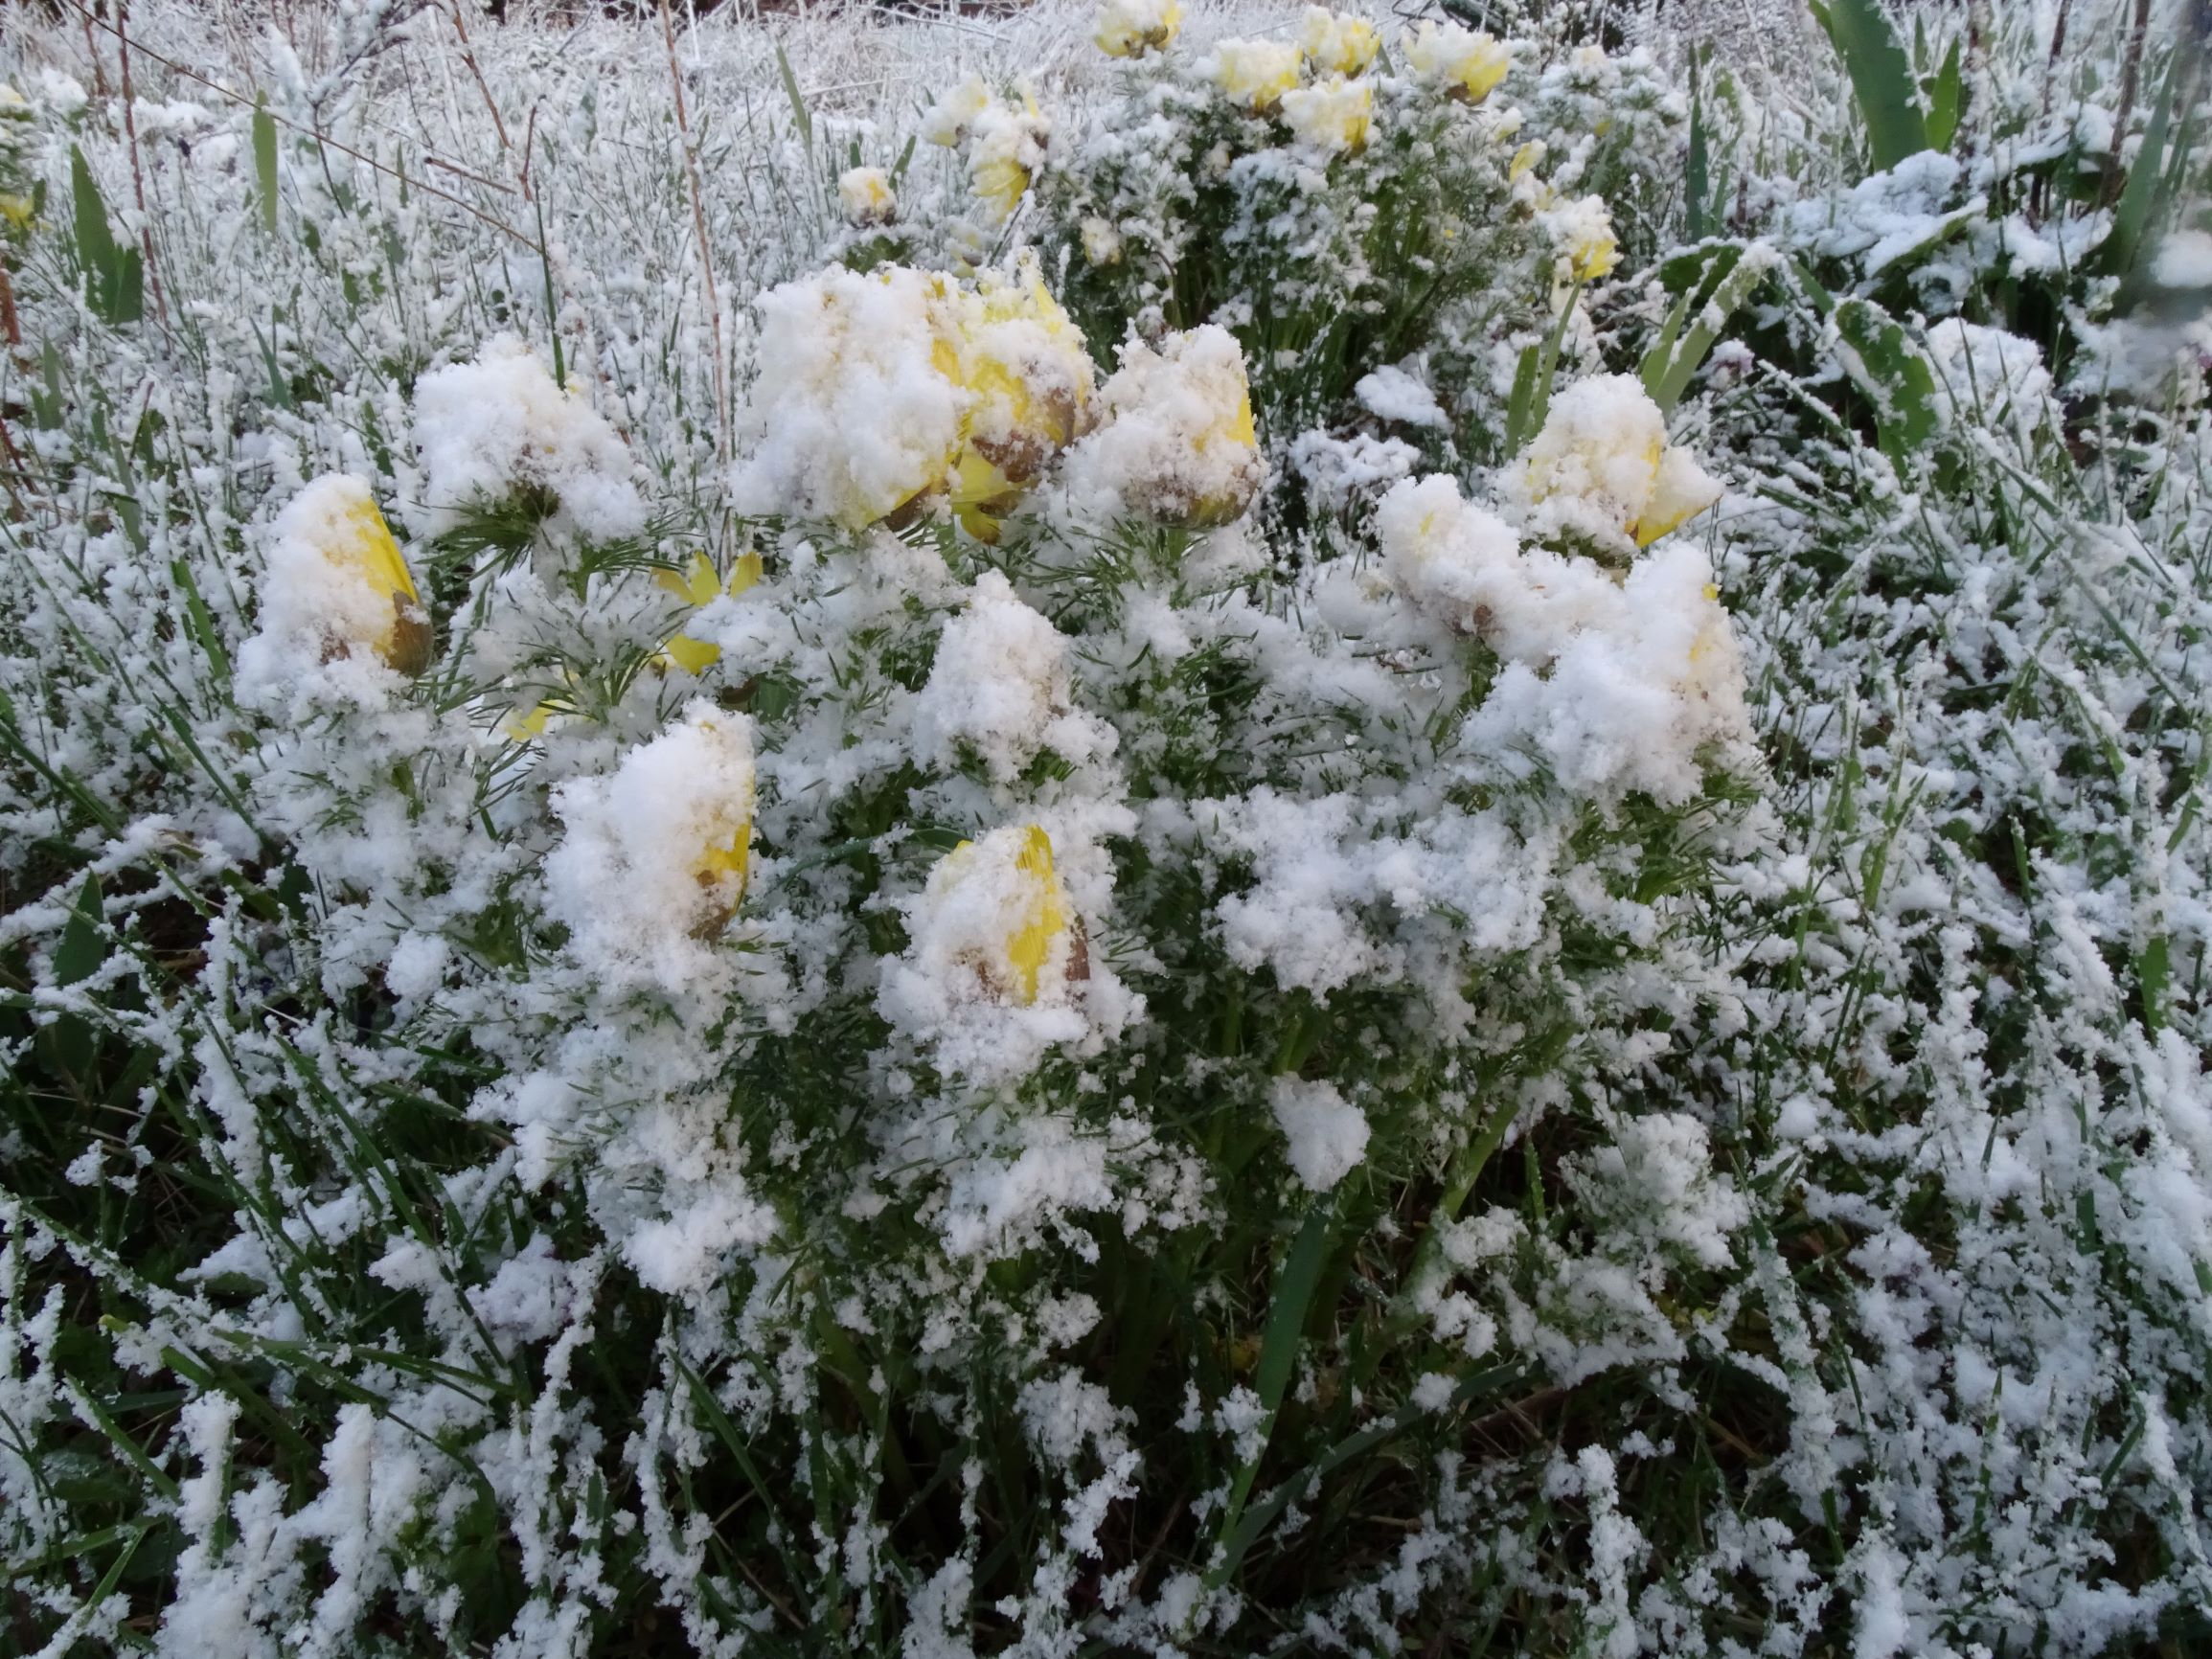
[1064,323,1263,529]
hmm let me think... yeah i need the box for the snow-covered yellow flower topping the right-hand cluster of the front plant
[1522,374,1721,546]
